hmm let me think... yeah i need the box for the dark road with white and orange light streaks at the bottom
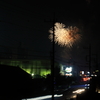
[22,85,85,100]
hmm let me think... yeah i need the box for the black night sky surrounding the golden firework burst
[0,0,100,65]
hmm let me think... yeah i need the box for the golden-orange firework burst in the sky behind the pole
[49,23,81,47]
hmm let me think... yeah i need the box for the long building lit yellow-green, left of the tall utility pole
[0,59,60,77]
